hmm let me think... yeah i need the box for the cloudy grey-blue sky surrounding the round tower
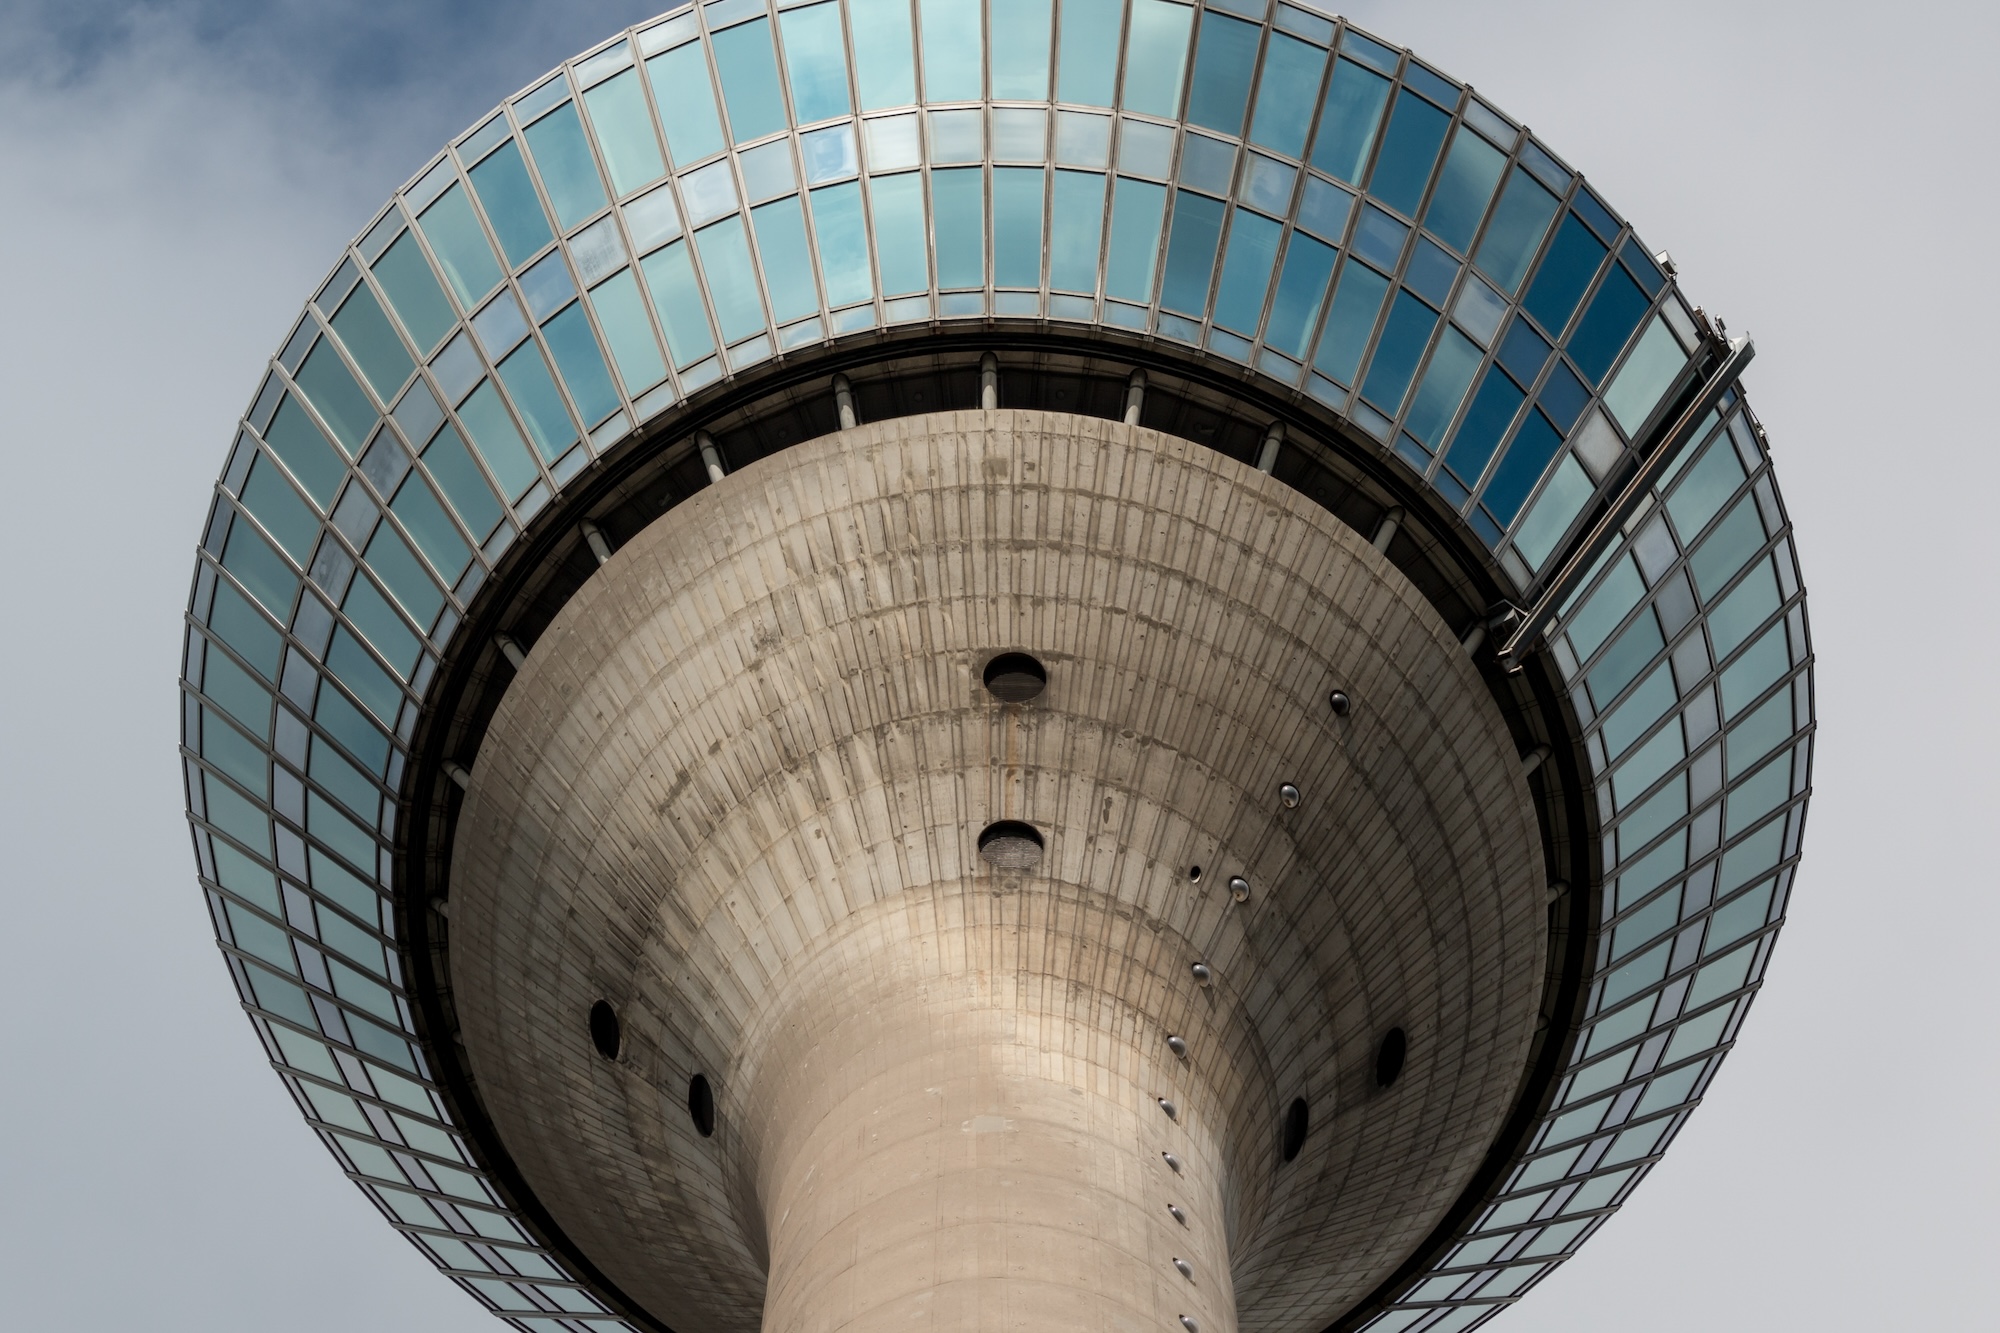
[0,0,2000,1333]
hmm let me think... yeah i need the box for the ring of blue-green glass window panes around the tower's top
[184,0,1812,1329]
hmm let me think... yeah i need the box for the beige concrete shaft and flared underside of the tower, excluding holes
[450,412,1546,1333]
